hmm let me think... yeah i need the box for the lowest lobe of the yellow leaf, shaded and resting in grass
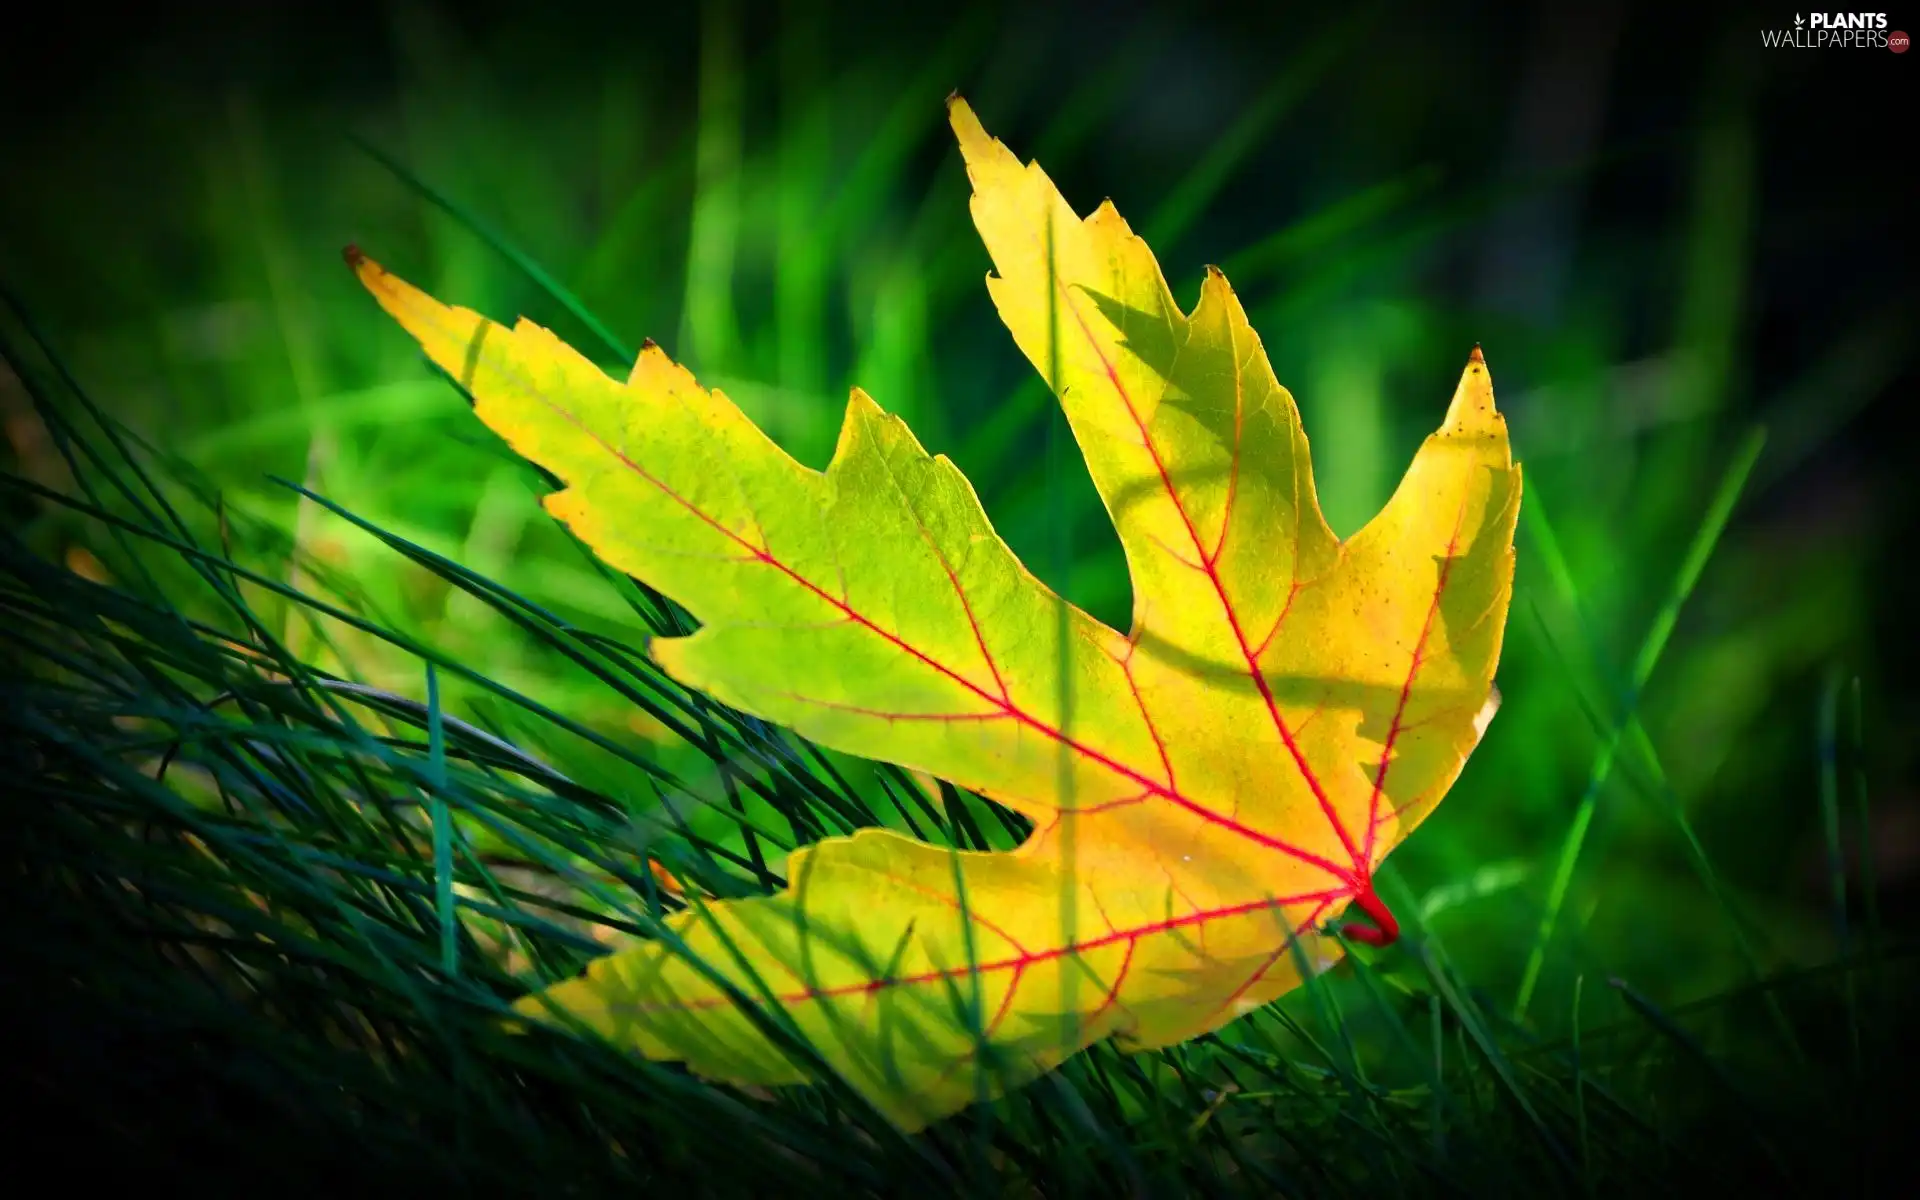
[516,829,1336,1129]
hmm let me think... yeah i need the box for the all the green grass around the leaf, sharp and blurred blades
[0,6,1914,1196]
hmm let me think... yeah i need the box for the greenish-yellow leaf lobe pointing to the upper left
[357,253,1158,822]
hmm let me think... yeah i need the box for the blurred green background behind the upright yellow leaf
[0,0,1920,1029]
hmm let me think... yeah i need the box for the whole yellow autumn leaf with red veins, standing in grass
[349,100,1521,1129]
